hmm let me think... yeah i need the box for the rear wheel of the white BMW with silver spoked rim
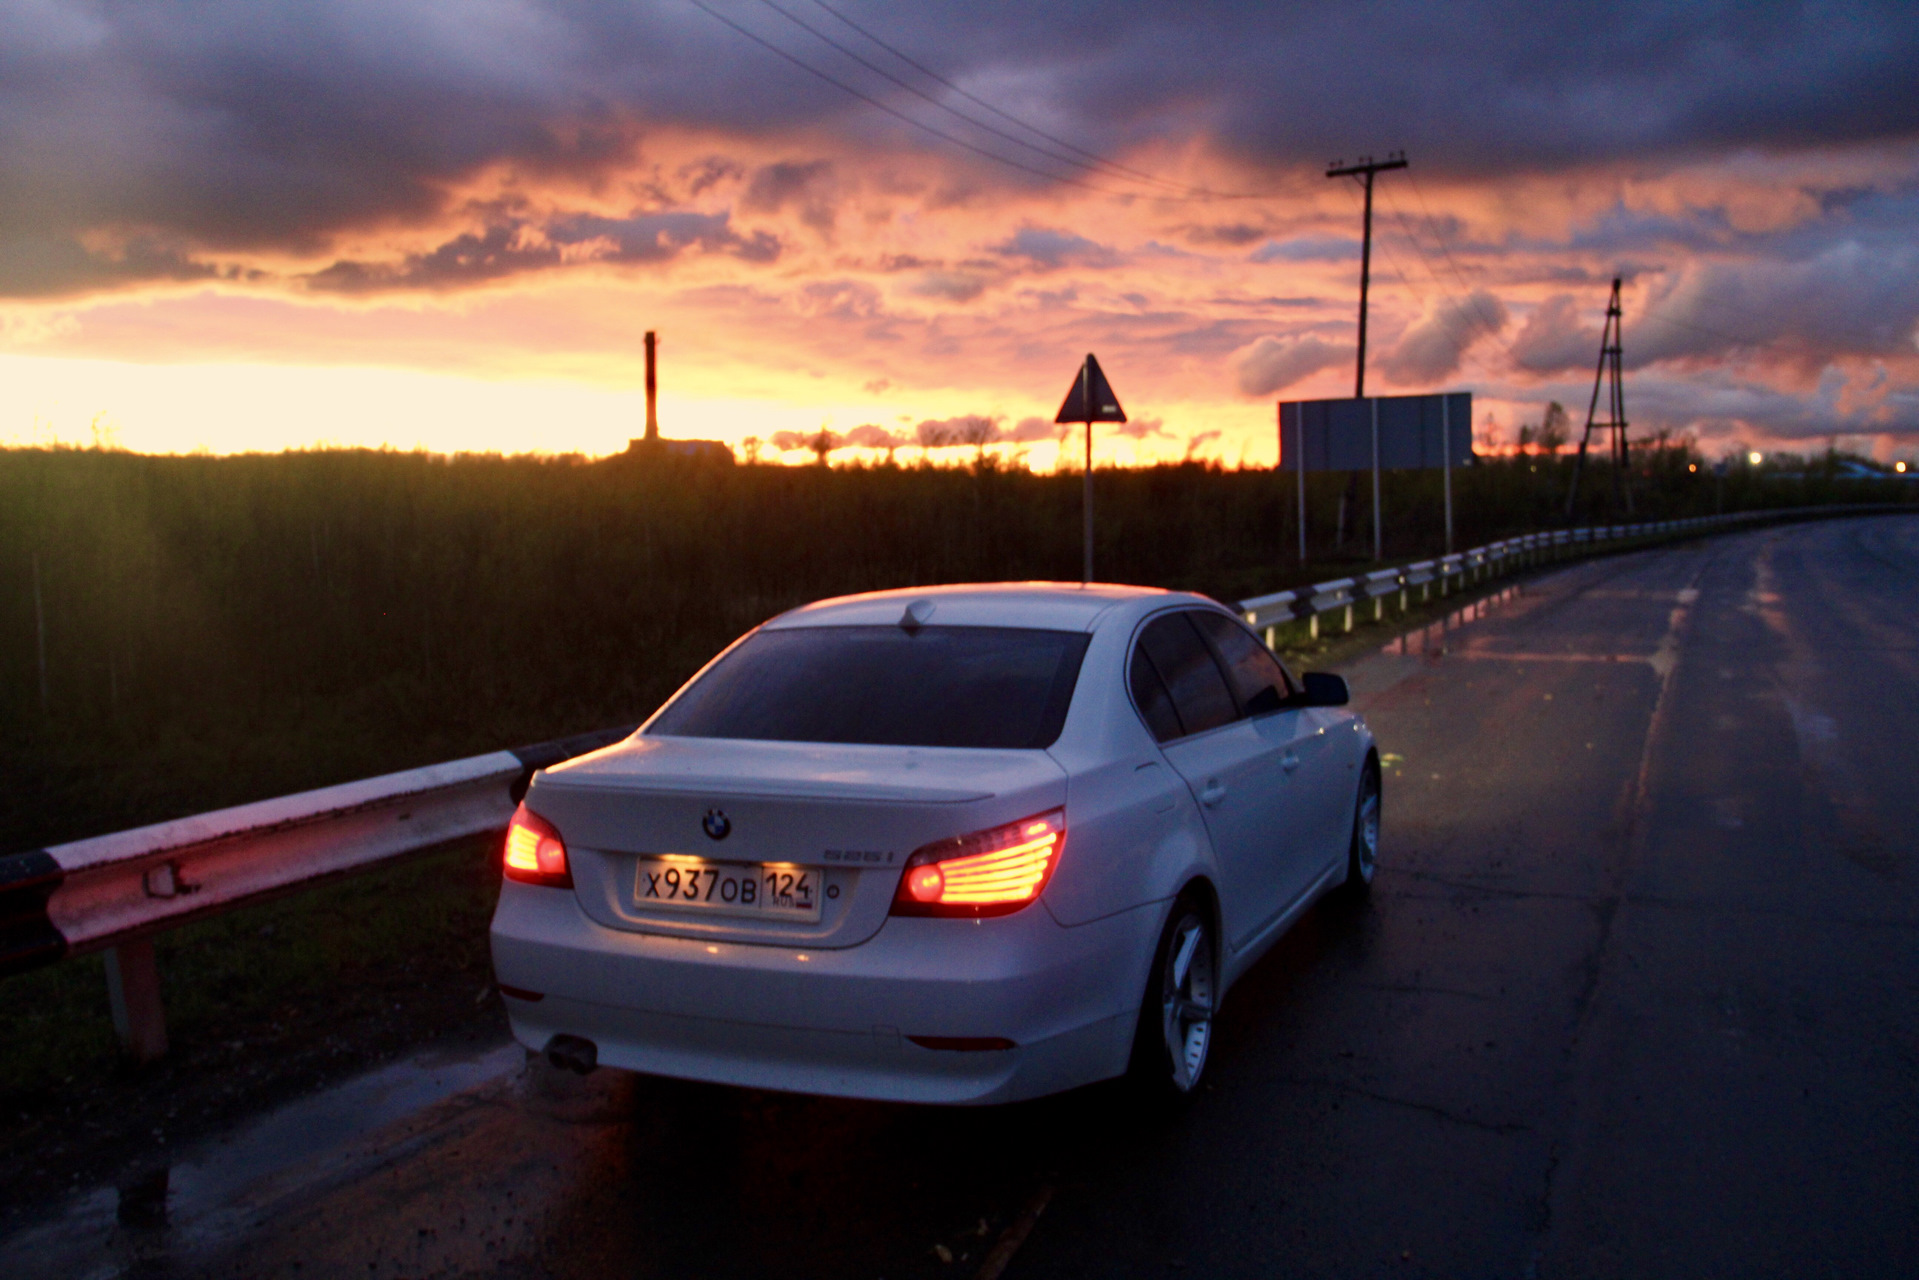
[1132,896,1219,1098]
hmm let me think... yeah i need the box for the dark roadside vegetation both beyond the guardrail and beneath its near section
[0,441,1919,1199]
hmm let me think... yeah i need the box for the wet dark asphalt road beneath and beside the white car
[0,516,1919,1278]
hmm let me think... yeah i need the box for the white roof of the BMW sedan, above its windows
[766,581,1213,631]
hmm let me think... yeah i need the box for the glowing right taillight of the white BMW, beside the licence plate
[892,810,1067,915]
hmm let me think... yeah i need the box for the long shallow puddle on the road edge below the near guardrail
[0,1044,526,1280]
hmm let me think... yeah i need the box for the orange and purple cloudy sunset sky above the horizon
[0,0,1919,466]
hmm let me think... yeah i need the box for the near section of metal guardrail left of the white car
[0,725,637,1061]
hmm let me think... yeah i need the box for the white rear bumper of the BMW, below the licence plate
[491,881,1159,1103]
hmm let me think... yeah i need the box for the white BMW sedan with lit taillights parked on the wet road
[491,583,1380,1103]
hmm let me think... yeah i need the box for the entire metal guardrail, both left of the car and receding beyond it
[0,505,1911,1061]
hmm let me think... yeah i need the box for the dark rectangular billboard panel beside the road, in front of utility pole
[1280,391,1472,470]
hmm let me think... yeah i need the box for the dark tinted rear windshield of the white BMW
[647,626,1088,748]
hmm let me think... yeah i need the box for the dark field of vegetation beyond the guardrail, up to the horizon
[0,441,1919,850]
